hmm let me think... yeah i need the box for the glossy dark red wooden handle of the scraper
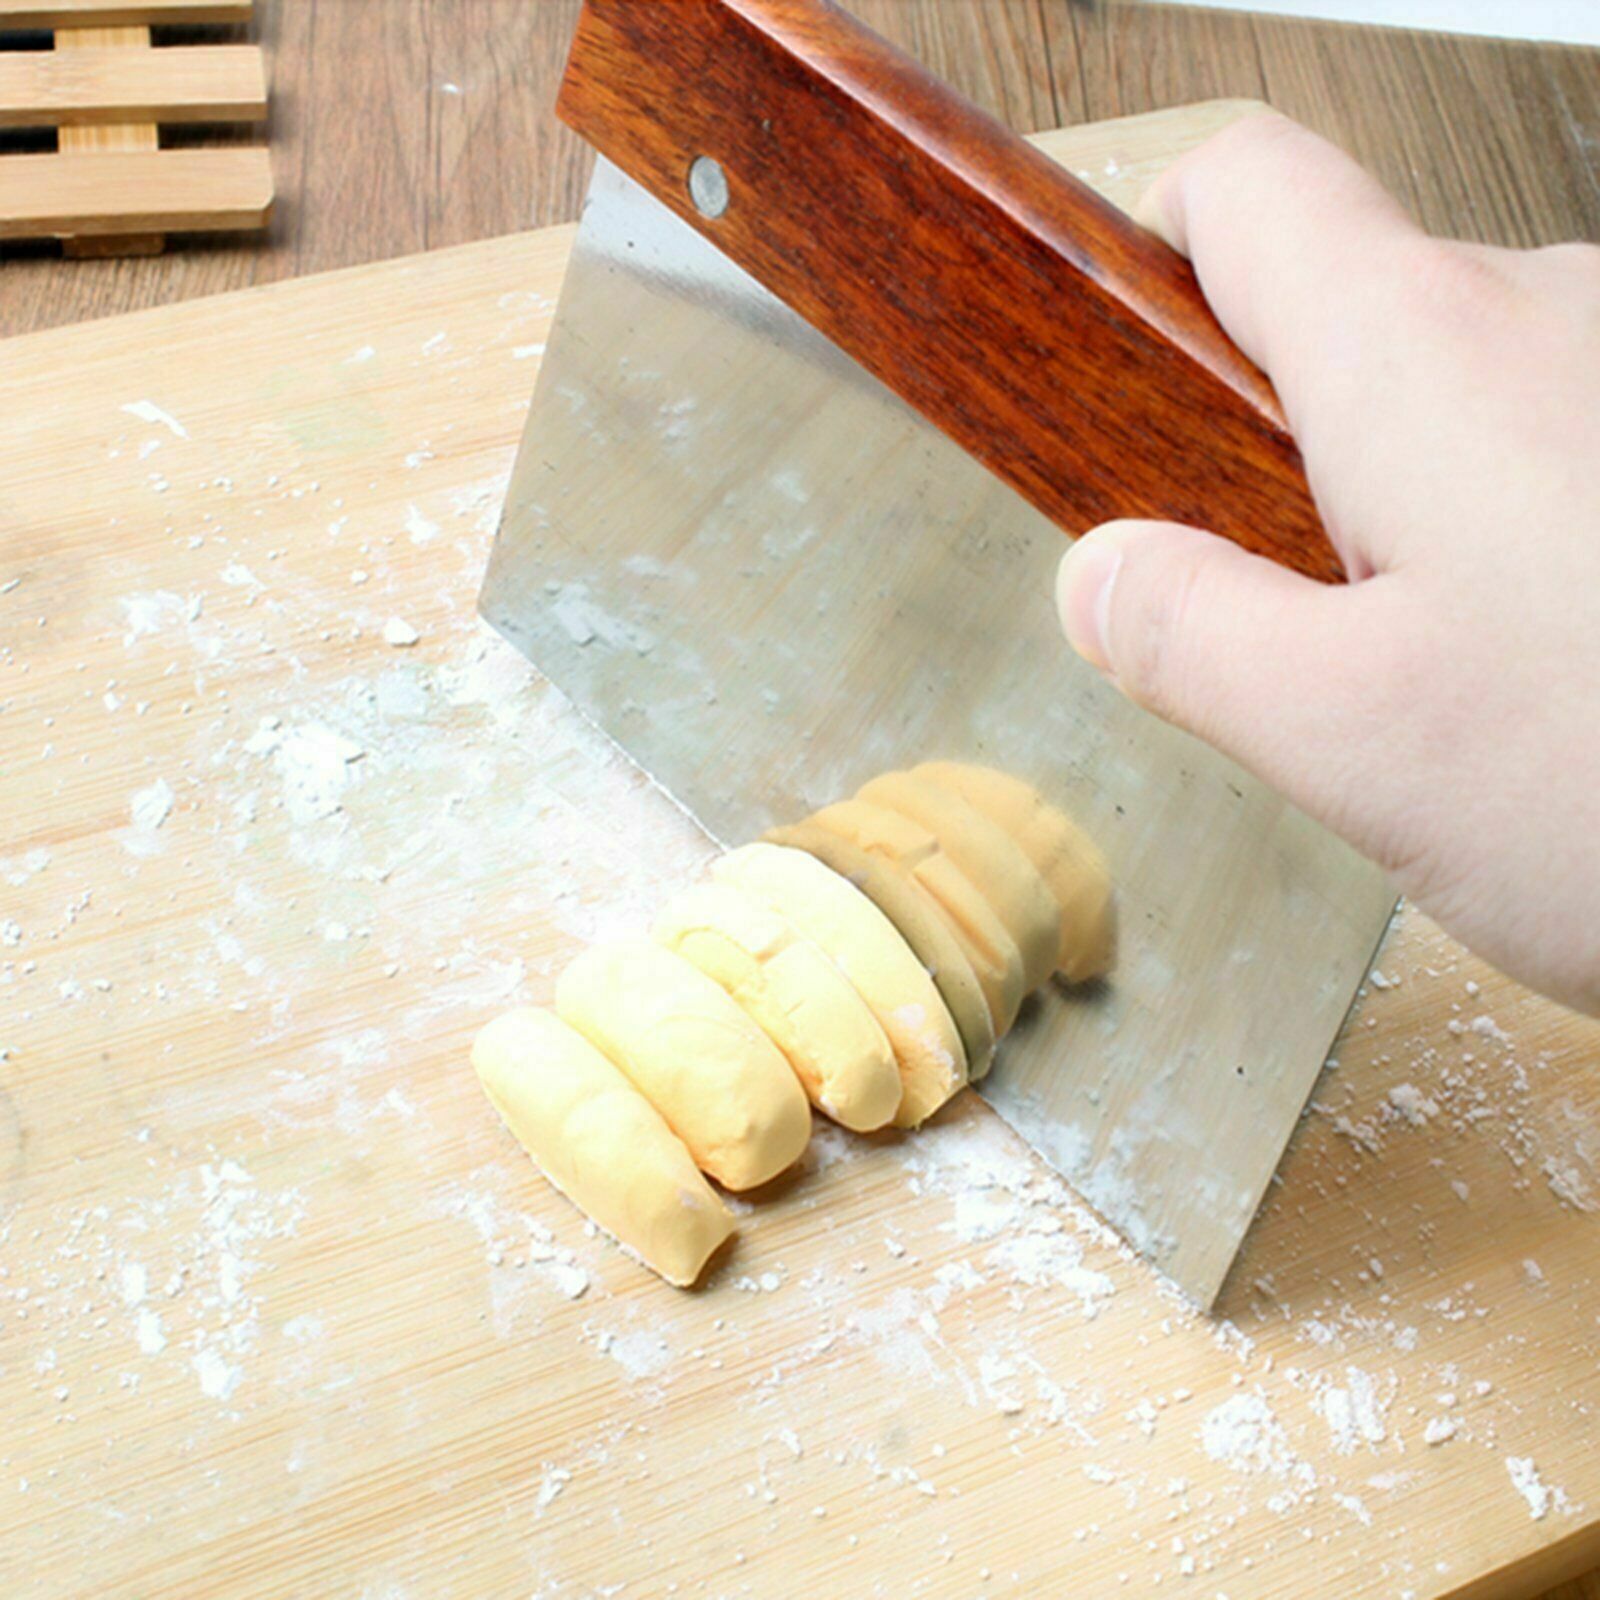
[558,0,1344,581]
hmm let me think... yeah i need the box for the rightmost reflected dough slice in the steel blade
[917,762,1117,982]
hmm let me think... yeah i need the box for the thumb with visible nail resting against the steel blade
[1056,522,1395,845]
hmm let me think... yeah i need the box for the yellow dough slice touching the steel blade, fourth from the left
[710,845,966,1128]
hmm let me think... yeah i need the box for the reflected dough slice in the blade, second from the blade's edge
[811,800,1027,1038]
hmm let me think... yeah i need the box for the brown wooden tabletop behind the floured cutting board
[0,0,1600,1600]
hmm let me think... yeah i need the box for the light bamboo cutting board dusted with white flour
[0,106,1600,1600]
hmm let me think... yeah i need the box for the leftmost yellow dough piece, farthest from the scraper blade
[472,1008,733,1286]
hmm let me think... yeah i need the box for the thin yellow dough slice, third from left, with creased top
[651,883,901,1133]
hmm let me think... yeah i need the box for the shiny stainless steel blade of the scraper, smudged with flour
[482,162,1394,1306]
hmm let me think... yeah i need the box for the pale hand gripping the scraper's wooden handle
[1058,115,1600,1013]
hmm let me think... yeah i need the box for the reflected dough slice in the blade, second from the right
[858,770,1061,989]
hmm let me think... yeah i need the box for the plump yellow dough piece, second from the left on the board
[555,939,811,1189]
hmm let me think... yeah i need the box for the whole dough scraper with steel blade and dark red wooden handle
[482,0,1394,1306]
